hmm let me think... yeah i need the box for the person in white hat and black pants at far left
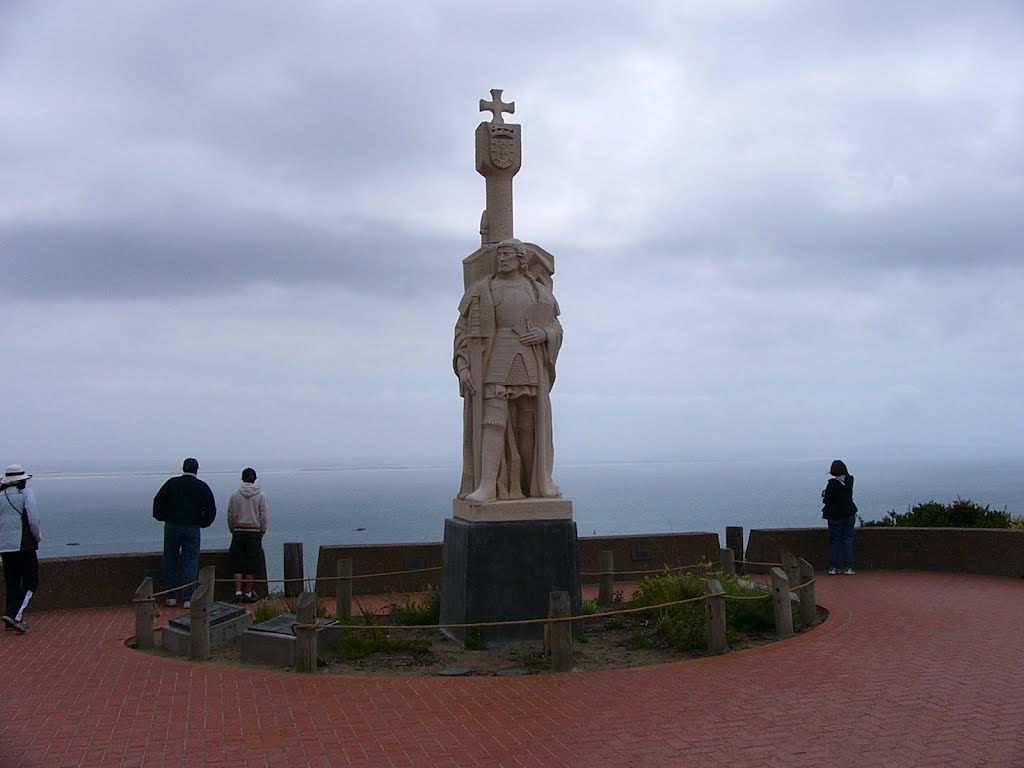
[0,464,42,635]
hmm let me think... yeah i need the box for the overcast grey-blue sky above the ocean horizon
[0,0,1024,464]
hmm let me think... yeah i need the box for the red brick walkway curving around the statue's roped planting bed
[0,572,1024,768]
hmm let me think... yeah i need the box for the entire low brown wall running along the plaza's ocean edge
[12,526,1024,610]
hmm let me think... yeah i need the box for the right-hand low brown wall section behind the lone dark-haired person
[746,526,1024,577]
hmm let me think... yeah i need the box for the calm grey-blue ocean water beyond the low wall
[18,458,1024,579]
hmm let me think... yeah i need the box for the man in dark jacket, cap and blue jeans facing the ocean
[153,459,217,608]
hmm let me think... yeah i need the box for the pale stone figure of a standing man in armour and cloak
[453,239,562,504]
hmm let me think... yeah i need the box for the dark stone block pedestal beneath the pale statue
[441,518,582,644]
